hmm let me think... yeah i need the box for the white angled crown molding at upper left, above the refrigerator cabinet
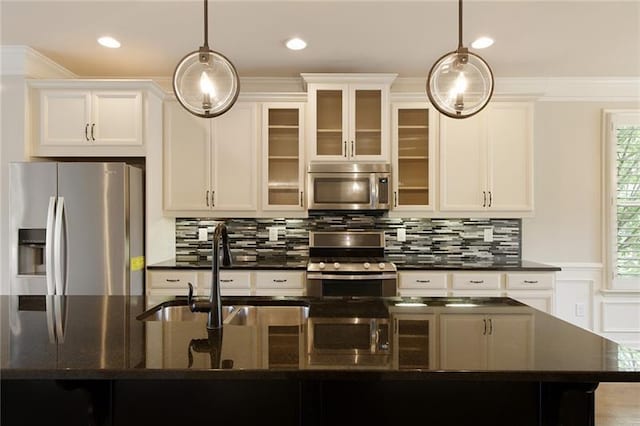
[0,46,77,78]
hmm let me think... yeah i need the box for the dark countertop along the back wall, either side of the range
[147,256,560,272]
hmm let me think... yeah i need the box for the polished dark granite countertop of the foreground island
[0,296,640,382]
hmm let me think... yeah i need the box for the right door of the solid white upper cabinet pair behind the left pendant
[211,102,258,211]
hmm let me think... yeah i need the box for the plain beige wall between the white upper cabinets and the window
[522,102,638,263]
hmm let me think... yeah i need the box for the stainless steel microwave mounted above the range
[307,163,391,210]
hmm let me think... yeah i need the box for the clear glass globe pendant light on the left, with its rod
[173,0,240,118]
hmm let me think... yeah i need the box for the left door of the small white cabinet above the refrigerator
[40,90,91,146]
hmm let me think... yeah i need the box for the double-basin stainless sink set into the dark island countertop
[137,300,309,326]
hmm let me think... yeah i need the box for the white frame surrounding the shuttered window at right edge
[602,109,640,292]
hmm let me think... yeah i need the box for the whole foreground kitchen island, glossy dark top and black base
[0,296,640,425]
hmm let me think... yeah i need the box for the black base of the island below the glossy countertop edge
[1,377,597,426]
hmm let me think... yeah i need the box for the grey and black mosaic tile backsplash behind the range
[176,212,522,263]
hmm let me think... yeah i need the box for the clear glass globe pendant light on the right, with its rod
[427,0,493,118]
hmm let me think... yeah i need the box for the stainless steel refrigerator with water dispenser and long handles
[9,162,144,296]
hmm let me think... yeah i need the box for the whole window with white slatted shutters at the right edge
[605,111,640,290]
